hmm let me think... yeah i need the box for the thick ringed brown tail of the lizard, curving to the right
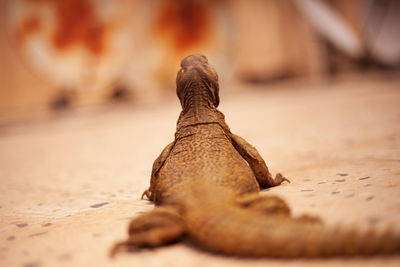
[184,187,400,258]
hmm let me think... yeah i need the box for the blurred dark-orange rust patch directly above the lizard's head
[155,0,212,52]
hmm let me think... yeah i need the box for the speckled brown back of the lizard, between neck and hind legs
[155,123,259,203]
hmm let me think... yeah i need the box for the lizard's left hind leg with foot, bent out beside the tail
[110,207,185,257]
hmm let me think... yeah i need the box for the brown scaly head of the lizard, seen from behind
[176,54,219,107]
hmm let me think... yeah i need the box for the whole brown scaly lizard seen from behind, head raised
[112,55,400,258]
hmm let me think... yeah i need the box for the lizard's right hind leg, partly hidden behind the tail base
[237,193,290,216]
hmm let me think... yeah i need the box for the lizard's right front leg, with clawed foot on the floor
[229,133,290,187]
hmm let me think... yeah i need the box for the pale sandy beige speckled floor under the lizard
[0,77,400,267]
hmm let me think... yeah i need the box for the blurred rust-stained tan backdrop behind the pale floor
[0,0,400,124]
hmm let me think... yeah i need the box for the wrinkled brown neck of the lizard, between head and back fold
[176,85,229,131]
